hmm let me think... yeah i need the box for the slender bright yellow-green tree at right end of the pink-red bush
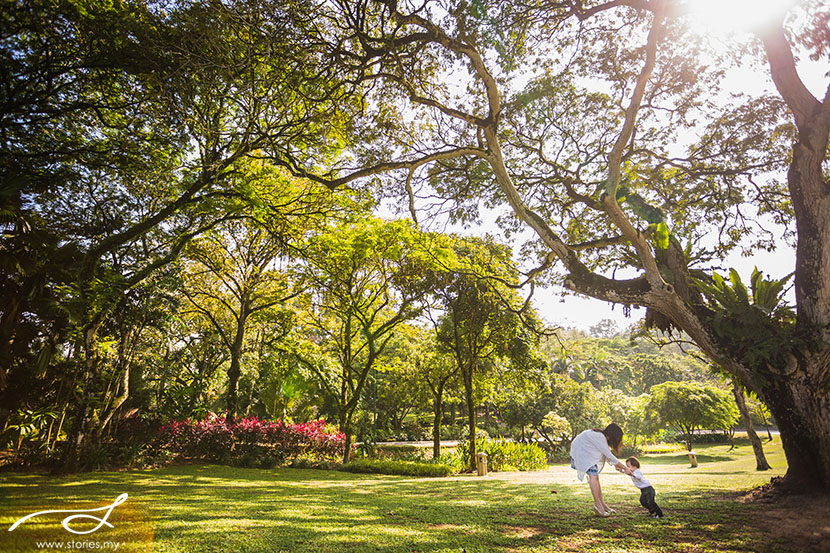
[292,217,442,462]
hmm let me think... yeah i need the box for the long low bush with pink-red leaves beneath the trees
[159,414,346,466]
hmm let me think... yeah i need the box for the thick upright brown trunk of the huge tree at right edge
[761,20,830,489]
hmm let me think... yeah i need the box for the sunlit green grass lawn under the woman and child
[0,437,830,553]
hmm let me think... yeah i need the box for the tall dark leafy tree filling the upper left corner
[0,0,360,469]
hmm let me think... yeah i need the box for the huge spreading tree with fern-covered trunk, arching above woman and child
[284,0,830,487]
